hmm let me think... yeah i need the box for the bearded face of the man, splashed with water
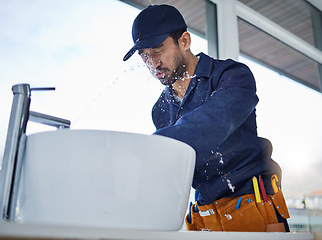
[139,37,186,85]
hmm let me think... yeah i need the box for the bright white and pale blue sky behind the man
[0,0,322,204]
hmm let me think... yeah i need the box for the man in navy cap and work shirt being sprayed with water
[123,5,289,231]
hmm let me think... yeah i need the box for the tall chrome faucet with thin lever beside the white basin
[0,84,70,221]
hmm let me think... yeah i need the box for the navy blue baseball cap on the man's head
[123,4,187,61]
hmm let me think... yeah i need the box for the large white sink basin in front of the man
[16,130,195,230]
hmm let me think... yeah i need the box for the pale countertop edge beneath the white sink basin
[0,222,313,240]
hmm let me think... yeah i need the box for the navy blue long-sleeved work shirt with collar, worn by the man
[152,53,281,204]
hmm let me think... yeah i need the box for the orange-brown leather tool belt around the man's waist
[185,189,290,232]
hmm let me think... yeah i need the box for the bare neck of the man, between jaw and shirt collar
[172,54,198,98]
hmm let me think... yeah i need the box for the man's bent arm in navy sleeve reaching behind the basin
[155,63,258,151]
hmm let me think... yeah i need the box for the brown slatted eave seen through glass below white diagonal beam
[238,19,320,91]
